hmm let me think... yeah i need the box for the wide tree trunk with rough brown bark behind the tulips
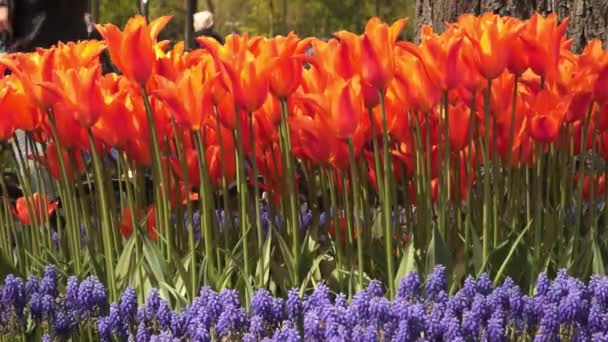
[416,0,608,52]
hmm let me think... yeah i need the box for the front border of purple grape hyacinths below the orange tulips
[0,266,608,342]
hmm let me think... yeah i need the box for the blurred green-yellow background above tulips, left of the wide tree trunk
[92,0,415,39]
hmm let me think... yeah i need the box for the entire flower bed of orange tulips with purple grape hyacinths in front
[0,9,608,342]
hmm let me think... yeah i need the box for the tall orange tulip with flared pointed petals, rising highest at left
[96,15,171,84]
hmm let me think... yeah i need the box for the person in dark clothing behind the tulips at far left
[0,0,88,52]
